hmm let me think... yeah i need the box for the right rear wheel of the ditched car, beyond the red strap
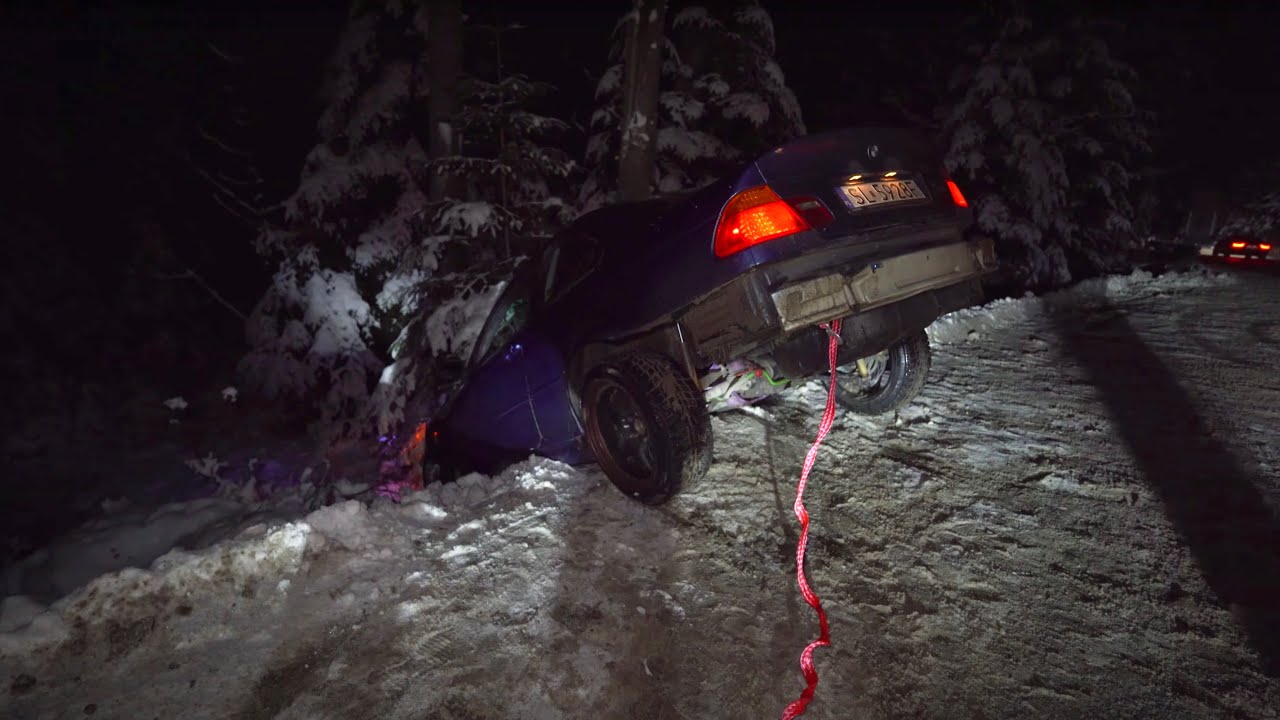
[836,331,932,415]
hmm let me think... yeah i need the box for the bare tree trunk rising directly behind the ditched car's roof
[618,0,667,202]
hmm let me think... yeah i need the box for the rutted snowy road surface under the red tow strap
[0,265,1280,720]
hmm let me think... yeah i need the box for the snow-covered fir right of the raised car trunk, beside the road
[942,13,1148,288]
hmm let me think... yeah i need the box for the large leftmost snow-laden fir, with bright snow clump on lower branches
[239,3,436,438]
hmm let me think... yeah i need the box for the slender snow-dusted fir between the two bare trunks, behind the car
[372,19,579,433]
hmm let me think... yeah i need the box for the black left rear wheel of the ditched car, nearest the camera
[582,352,712,505]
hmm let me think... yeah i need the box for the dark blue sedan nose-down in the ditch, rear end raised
[428,128,996,503]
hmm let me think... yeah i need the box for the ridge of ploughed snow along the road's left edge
[0,459,588,652]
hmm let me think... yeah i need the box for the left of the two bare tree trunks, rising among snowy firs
[426,0,462,202]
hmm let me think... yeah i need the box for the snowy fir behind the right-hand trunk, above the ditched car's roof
[580,0,805,210]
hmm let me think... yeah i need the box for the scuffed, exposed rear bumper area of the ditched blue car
[676,228,996,363]
